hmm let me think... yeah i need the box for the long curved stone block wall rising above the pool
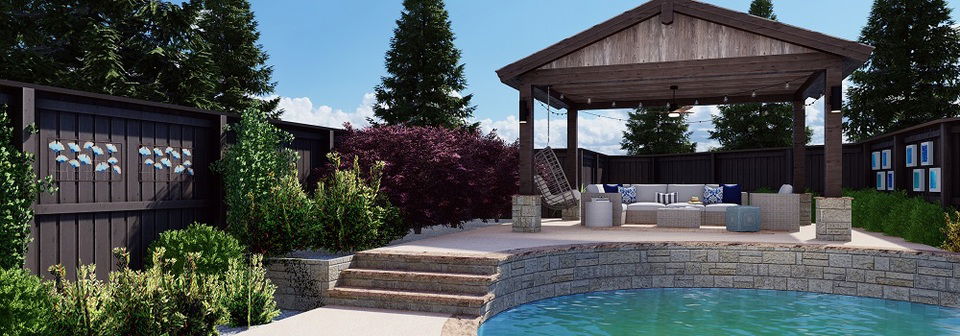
[481,243,960,320]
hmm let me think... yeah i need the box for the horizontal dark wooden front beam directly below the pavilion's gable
[522,53,840,86]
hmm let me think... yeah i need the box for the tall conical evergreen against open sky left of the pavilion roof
[371,0,477,128]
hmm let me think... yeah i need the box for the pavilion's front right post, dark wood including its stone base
[817,62,853,241]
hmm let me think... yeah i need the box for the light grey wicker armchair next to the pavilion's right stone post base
[749,193,811,232]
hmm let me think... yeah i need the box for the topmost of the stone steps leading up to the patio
[351,250,502,275]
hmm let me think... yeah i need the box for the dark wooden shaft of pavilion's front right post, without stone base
[823,62,843,197]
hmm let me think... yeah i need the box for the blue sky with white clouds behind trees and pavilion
[251,0,960,154]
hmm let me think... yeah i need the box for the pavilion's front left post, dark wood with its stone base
[513,84,541,232]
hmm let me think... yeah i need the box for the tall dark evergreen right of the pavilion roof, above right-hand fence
[844,0,960,140]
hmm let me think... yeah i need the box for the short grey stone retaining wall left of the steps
[267,256,353,310]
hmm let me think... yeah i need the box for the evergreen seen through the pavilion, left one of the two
[620,107,697,155]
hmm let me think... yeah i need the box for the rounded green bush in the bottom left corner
[0,269,54,336]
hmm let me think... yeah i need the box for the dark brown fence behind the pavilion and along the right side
[556,118,960,207]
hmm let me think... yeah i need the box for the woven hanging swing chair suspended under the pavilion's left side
[533,87,580,210]
